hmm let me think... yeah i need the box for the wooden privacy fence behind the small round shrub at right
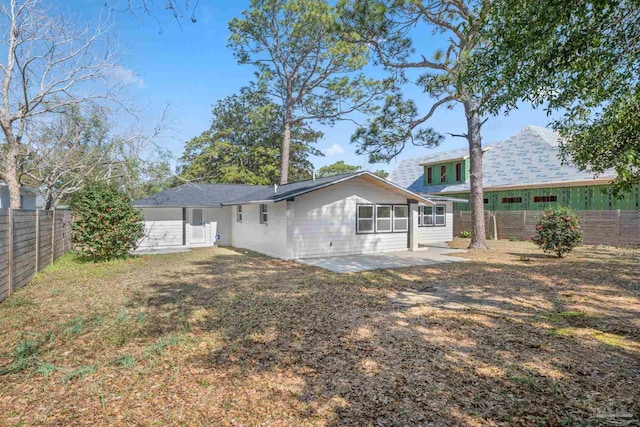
[453,210,640,246]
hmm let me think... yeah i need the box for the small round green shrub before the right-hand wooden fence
[531,206,582,258]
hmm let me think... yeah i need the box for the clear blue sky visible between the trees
[70,0,549,175]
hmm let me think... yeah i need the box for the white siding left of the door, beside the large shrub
[139,208,182,248]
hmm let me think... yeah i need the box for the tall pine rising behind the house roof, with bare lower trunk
[229,0,384,184]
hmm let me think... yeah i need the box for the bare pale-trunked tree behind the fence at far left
[0,0,122,208]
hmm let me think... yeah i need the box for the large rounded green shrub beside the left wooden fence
[71,184,144,261]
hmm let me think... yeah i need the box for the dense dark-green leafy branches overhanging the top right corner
[466,0,640,194]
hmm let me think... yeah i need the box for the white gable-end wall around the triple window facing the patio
[291,178,407,258]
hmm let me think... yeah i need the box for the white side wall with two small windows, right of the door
[231,202,288,258]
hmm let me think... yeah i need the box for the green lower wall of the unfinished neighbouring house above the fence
[443,185,640,211]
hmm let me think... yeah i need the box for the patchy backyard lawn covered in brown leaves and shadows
[0,240,640,426]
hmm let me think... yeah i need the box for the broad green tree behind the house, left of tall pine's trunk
[179,87,323,185]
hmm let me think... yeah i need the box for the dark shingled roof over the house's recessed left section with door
[133,183,266,207]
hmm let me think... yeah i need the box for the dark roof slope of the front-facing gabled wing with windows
[223,171,368,205]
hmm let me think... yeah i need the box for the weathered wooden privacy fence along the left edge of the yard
[0,209,72,301]
